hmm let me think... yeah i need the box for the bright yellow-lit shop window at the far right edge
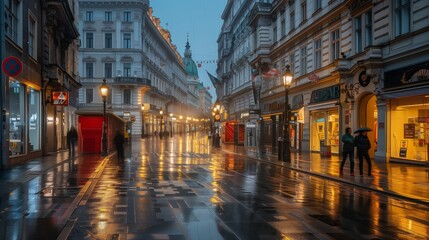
[390,96,429,161]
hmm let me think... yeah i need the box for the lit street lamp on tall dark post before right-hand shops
[278,65,293,162]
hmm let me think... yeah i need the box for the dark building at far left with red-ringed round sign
[0,1,80,168]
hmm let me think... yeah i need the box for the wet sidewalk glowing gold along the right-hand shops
[221,144,429,205]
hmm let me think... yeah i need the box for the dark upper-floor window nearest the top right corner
[395,0,411,36]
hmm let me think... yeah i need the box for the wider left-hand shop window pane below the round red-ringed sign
[9,80,26,156]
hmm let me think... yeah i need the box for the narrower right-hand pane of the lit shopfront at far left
[28,88,41,152]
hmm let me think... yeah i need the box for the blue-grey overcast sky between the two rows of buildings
[150,0,227,99]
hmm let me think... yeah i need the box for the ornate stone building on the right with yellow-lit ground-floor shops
[218,0,429,164]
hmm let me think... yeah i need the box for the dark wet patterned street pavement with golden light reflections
[0,134,429,239]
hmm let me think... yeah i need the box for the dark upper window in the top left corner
[4,0,20,42]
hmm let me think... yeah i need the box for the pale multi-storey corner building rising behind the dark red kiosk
[79,0,210,140]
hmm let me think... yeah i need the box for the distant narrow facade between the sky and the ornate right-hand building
[215,0,271,146]
